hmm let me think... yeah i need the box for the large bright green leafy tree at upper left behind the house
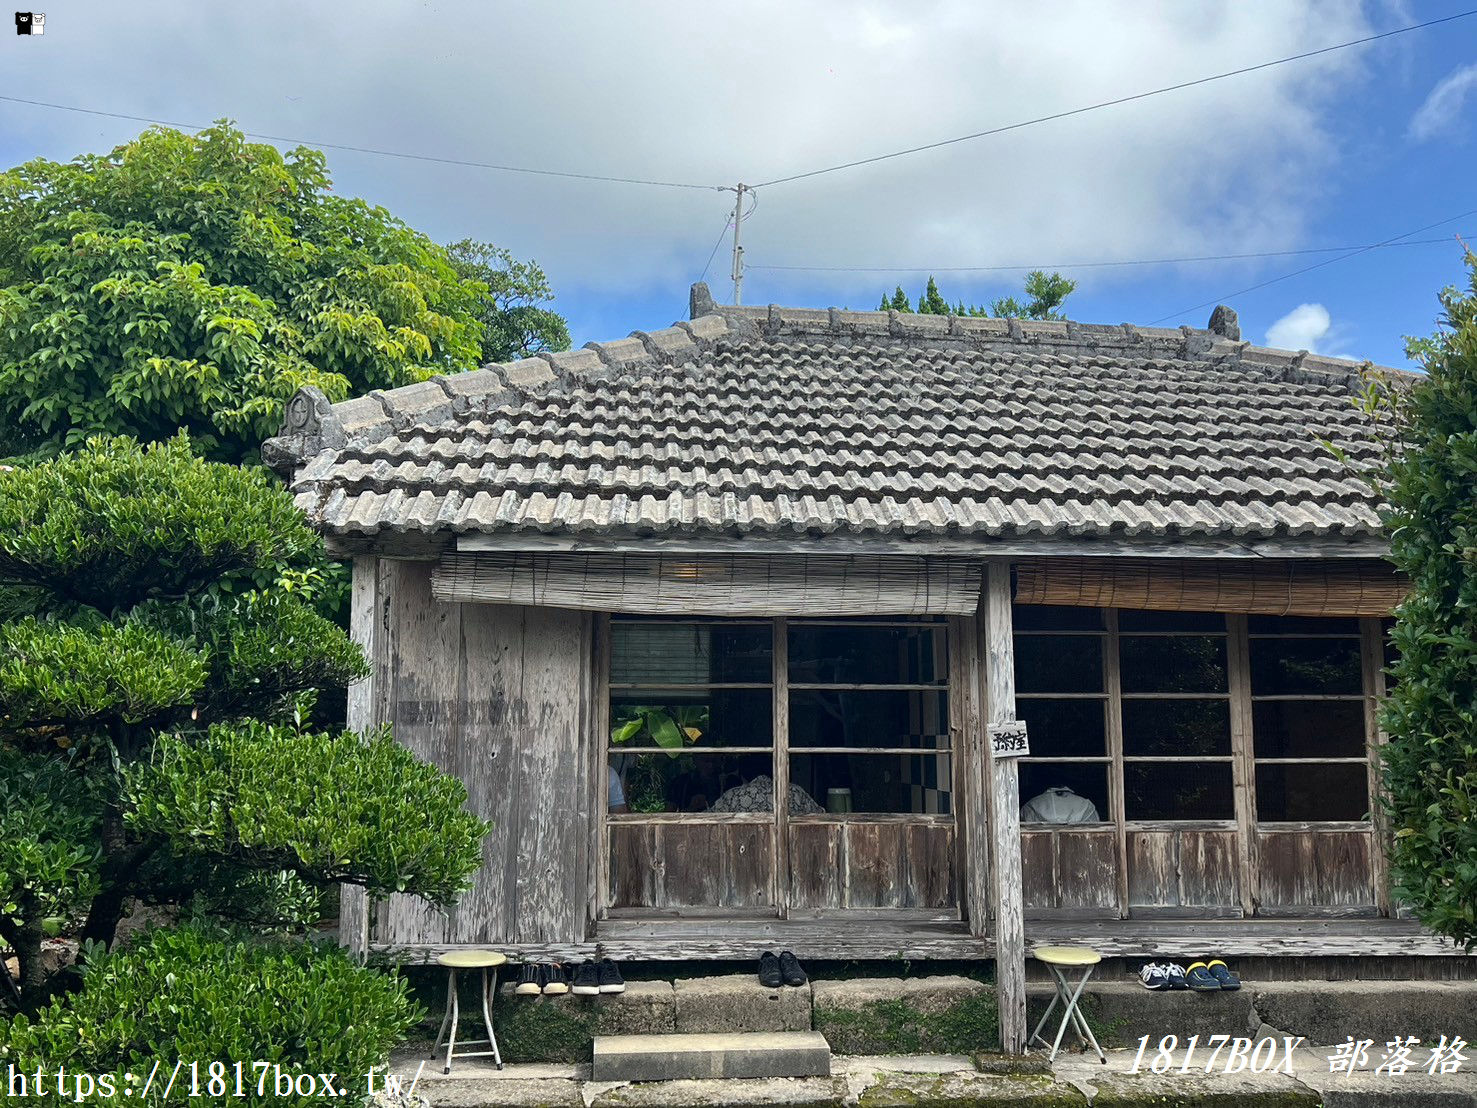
[0,123,493,461]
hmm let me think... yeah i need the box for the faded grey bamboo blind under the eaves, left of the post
[431,553,982,616]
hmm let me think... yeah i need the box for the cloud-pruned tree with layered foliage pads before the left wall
[0,434,486,1006]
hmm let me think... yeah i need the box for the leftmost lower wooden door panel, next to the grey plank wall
[610,821,774,909]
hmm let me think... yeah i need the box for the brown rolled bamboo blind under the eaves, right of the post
[1015,558,1409,616]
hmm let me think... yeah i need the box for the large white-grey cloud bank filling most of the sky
[0,0,1372,316]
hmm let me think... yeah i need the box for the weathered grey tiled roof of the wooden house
[264,285,1406,552]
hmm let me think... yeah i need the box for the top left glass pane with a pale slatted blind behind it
[610,620,774,687]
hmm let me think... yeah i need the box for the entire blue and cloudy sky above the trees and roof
[0,0,1477,365]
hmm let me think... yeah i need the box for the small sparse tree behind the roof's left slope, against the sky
[446,238,569,362]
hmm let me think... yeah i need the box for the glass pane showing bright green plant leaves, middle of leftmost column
[610,688,774,750]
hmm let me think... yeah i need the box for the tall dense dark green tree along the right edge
[1371,254,1477,950]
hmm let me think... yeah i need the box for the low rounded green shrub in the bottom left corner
[0,920,422,1108]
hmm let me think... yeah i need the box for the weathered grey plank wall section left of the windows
[375,563,594,944]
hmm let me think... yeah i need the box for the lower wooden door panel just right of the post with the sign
[1021,827,1118,919]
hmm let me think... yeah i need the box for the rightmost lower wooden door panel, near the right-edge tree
[1257,830,1378,916]
